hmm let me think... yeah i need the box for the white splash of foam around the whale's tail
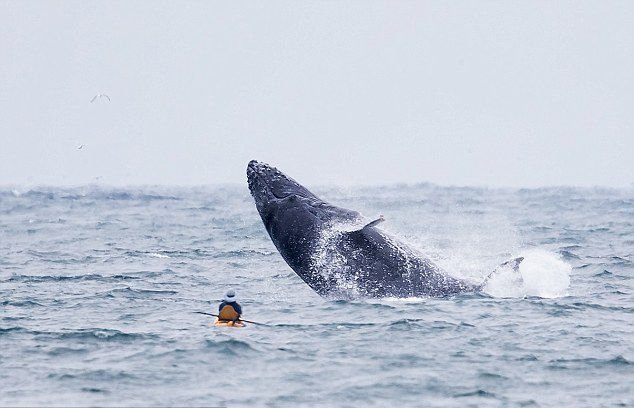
[484,249,572,298]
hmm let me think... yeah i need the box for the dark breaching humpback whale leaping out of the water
[247,160,522,298]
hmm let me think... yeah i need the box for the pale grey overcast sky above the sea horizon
[0,0,634,187]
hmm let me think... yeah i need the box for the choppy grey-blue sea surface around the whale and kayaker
[0,183,634,407]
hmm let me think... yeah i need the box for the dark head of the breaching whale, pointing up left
[247,160,359,237]
